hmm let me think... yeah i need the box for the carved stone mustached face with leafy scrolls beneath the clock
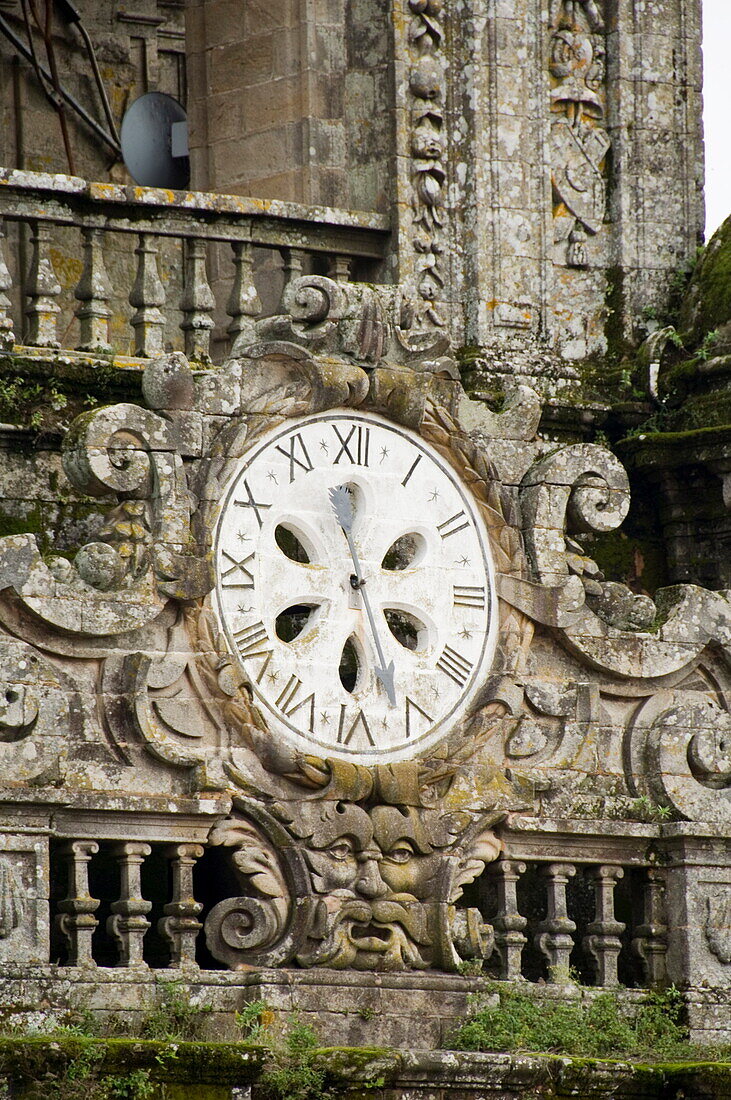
[206,767,500,970]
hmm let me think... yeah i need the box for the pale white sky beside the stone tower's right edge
[702,0,731,240]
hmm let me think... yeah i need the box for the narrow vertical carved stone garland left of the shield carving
[408,0,446,329]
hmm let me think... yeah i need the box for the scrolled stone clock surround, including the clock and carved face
[0,277,731,970]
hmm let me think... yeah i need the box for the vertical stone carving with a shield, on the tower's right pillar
[549,0,611,267]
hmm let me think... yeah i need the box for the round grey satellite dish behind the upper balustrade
[120,91,190,190]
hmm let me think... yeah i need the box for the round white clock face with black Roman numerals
[214,411,497,763]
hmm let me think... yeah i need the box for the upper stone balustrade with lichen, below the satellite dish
[0,169,388,363]
